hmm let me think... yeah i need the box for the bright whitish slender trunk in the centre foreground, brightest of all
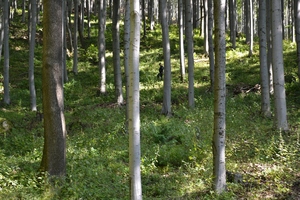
[128,0,142,200]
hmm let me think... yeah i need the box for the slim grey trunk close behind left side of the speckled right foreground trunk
[207,0,215,90]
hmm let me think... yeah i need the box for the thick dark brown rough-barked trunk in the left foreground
[41,0,66,176]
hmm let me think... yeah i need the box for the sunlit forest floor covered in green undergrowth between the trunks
[0,13,300,199]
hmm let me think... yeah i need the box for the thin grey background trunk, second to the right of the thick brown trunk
[73,0,79,75]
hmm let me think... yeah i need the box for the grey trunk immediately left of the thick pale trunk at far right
[259,0,271,117]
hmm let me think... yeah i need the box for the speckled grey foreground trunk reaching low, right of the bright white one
[212,0,226,193]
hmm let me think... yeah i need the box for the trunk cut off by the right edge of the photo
[294,0,300,81]
